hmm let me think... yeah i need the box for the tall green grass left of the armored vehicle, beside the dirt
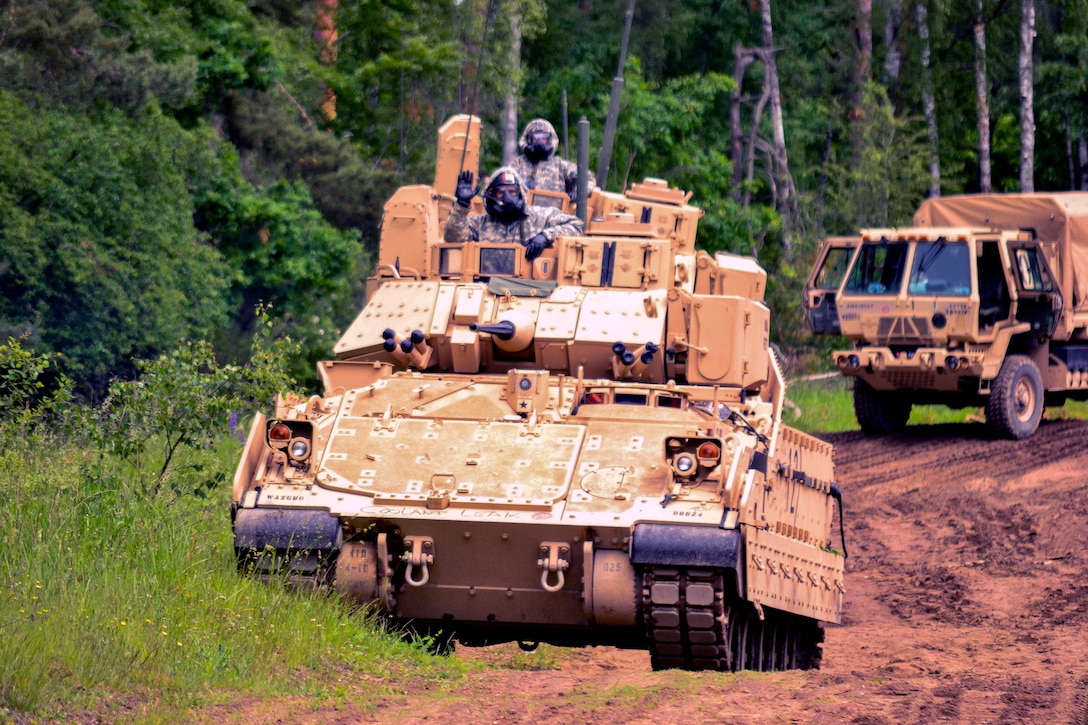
[0,428,463,722]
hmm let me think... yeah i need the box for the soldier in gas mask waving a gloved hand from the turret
[444,167,582,260]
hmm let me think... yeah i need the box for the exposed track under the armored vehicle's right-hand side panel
[642,566,824,672]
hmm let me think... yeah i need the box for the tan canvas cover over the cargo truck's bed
[914,192,1088,327]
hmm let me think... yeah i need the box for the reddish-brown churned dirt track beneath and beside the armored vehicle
[205,421,1088,725]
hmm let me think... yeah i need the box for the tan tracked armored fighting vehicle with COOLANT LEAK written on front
[233,116,844,671]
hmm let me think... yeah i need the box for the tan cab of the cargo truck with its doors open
[804,226,1063,438]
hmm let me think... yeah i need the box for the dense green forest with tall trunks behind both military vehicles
[0,0,1088,402]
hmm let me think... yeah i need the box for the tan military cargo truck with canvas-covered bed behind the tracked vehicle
[804,193,1088,439]
